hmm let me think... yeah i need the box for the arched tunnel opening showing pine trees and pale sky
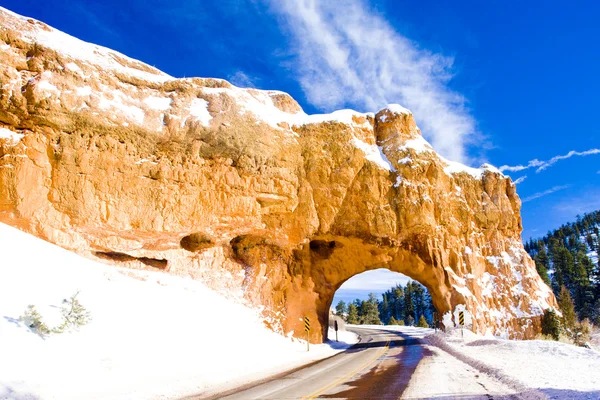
[328,268,437,339]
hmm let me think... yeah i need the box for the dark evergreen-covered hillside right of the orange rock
[525,210,600,324]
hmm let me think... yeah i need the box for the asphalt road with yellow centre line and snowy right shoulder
[206,328,512,400]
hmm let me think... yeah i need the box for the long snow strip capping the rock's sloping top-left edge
[0,7,175,83]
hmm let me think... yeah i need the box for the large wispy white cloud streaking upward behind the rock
[266,0,476,162]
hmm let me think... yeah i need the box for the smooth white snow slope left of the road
[0,224,357,400]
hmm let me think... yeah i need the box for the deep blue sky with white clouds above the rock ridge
[5,0,600,296]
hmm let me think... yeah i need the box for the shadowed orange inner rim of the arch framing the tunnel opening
[284,237,466,342]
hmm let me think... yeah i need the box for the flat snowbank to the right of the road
[425,330,600,399]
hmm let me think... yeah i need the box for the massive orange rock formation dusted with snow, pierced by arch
[0,9,556,342]
